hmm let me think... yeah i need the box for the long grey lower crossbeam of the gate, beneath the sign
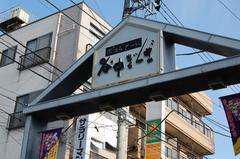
[24,56,240,121]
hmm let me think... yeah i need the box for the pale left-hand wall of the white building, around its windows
[0,12,58,159]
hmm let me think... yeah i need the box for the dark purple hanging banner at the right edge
[220,93,240,155]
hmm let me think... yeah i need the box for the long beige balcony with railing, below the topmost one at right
[166,100,214,155]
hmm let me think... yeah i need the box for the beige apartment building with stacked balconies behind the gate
[128,92,215,159]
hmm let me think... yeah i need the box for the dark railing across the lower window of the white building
[7,112,26,130]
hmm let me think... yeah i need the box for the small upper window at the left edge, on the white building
[0,46,17,66]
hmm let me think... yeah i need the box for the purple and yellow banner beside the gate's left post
[39,128,62,159]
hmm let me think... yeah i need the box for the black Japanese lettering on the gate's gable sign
[97,38,154,77]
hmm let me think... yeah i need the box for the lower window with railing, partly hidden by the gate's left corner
[8,91,42,129]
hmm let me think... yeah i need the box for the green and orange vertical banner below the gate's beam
[146,119,161,159]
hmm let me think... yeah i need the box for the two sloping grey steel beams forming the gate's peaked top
[33,16,240,107]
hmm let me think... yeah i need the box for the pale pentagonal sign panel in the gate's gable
[92,25,161,88]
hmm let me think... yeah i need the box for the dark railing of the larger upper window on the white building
[18,47,51,71]
